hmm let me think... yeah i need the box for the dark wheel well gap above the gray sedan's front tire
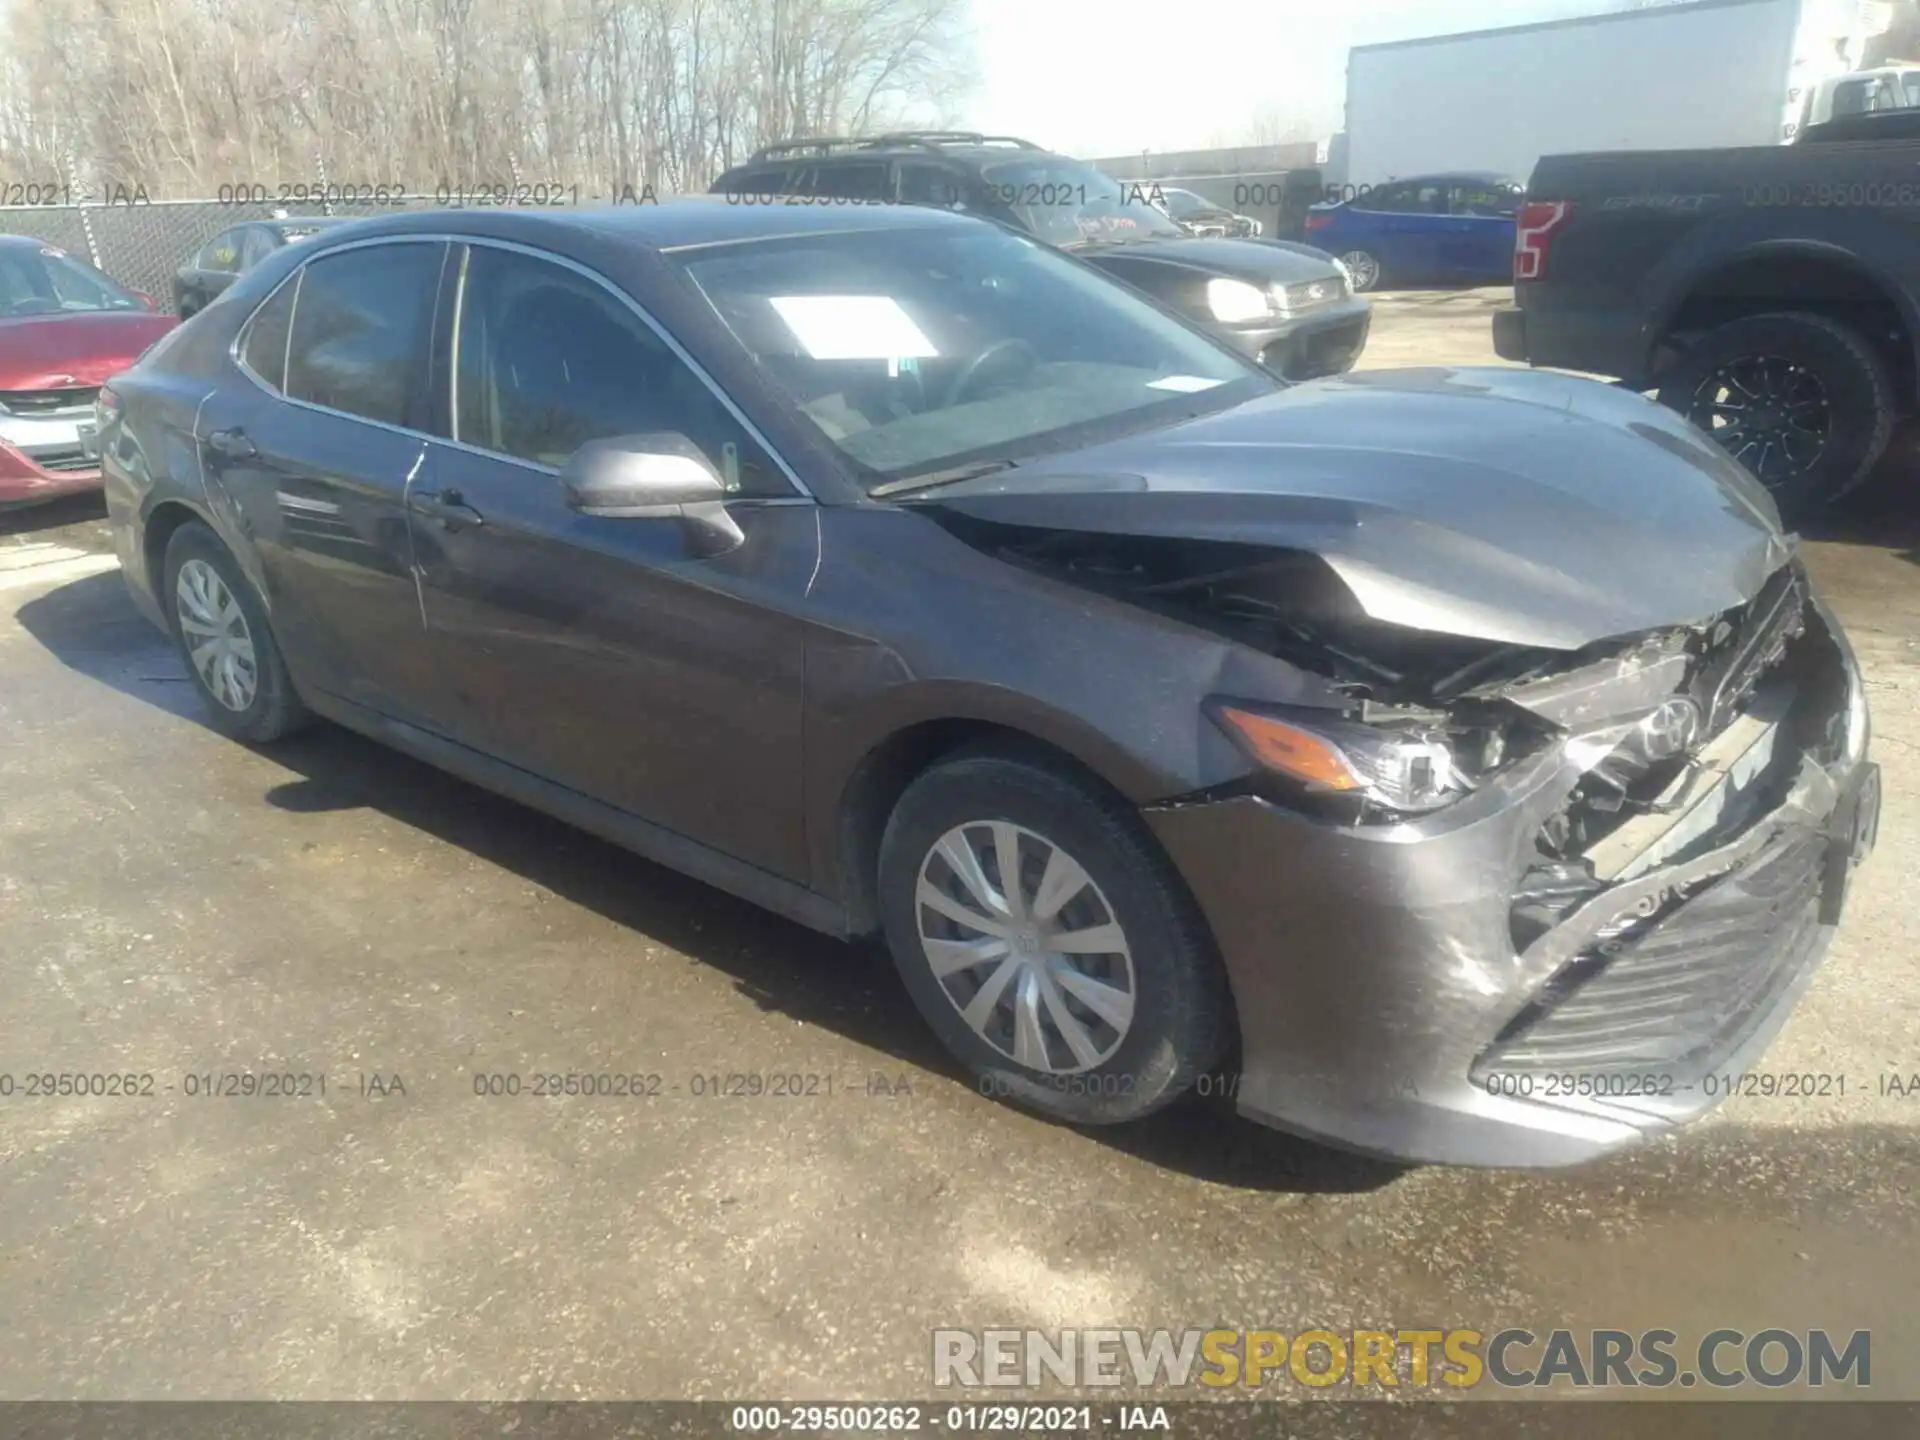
[837,720,1112,935]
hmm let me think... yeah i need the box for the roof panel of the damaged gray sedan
[276,196,987,250]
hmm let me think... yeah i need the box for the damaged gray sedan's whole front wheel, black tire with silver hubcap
[879,751,1231,1125]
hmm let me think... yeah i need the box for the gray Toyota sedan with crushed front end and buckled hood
[100,202,1880,1165]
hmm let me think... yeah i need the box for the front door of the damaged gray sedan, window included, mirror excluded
[411,244,818,879]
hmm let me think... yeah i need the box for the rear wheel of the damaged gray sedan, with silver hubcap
[163,520,307,743]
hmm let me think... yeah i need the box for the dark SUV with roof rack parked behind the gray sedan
[712,131,1373,380]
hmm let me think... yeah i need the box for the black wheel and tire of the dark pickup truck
[1659,313,1897,524]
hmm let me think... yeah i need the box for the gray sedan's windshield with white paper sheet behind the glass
[676,225,1277,488]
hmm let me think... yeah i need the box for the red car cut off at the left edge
[0,234,179,509]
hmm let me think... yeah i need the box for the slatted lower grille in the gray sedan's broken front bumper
[1473,828,1828,1079]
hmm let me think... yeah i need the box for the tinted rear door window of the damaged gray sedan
[286,244,445,424]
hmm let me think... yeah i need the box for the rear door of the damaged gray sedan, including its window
[196,238,447,733]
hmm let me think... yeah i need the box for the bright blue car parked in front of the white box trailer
[1306,173,1526,290]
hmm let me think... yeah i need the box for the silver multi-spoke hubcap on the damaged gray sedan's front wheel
[916,820,1135,1075]
